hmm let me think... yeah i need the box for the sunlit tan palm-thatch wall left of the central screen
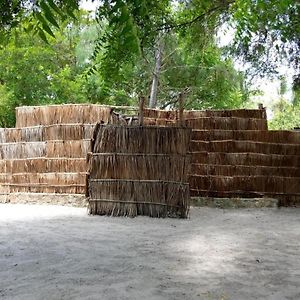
[0,105,111,194]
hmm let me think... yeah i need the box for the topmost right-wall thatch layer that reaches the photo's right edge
[192,130,300,144]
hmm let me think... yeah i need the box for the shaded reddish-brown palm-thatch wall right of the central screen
[144,109,300,205]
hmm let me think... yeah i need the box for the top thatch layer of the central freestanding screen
[92,125,191,155]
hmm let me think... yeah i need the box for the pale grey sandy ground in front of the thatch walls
[0,204,300,300]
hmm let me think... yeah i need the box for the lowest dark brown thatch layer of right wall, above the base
[190,175,300,194]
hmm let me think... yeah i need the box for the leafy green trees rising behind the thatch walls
[0,0,300,127]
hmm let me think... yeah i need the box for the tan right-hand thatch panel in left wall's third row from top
[46,140,90,158]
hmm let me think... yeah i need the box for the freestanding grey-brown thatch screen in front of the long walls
[88,125,191,218]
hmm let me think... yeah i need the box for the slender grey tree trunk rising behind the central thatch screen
[149,38,163,108]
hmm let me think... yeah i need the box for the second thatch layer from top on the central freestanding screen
[89,154,190,182]
